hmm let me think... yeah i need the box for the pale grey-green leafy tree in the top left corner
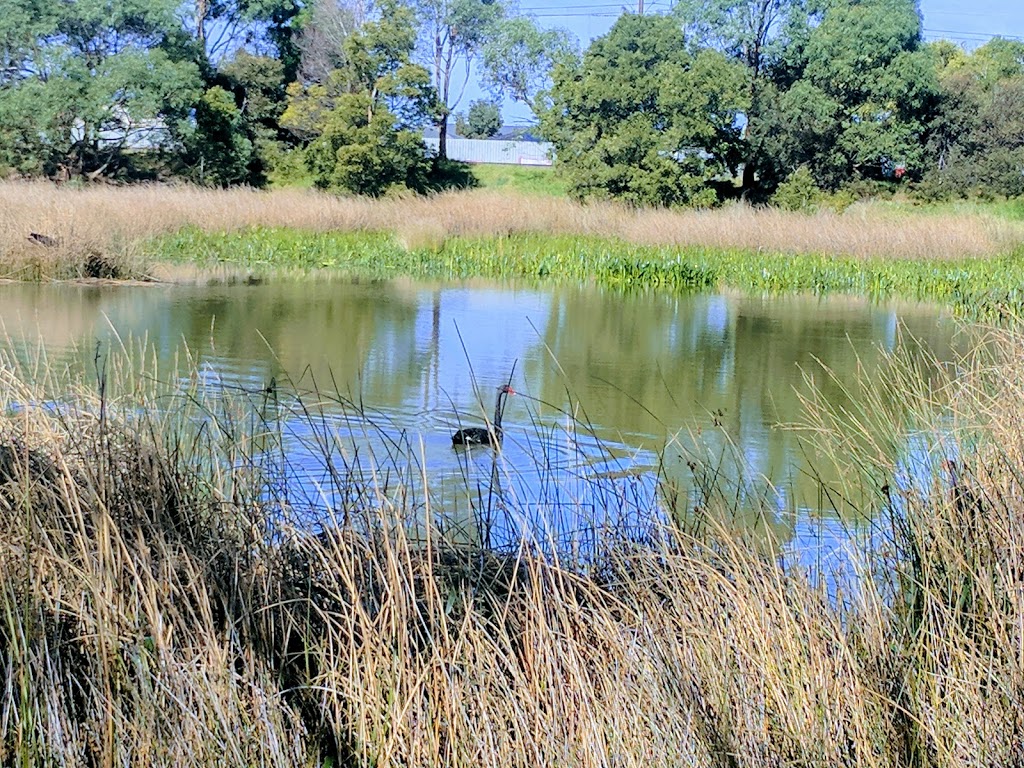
[0,0,200,177]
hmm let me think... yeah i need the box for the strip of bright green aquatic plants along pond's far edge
[146,228,1024,318]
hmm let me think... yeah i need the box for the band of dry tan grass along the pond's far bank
[0,182,1024,278]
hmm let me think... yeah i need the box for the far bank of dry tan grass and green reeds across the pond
[0,183,1024,305]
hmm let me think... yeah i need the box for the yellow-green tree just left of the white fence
[282,2,436,196]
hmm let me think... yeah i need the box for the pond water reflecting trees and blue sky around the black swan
[0,281,955,557]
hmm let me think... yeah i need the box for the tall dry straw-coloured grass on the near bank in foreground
[0,323,1024,768]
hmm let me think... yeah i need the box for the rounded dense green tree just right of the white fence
[541,14,746,205]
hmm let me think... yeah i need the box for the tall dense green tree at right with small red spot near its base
[760,0,938,188]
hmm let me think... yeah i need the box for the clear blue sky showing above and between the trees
[483,0,1024,123]
